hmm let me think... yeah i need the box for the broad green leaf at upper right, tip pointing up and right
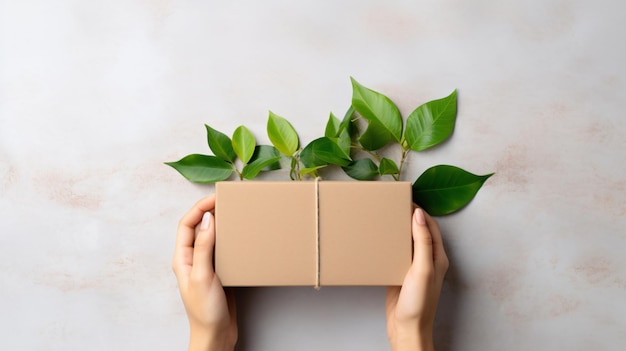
[404,90,457,151]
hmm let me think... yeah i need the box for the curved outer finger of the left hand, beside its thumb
[172,195,215,279]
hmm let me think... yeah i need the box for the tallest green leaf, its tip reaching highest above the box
[350,77,402,148]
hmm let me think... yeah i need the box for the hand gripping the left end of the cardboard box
[172,195,237,350]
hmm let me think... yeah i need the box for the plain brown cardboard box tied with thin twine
[215,181,412,286]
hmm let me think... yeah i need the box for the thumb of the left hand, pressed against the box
[191,212,215,280]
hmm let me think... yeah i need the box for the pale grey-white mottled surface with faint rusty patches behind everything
[0,0,626,351]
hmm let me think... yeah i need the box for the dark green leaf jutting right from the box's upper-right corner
[413,165,493,216]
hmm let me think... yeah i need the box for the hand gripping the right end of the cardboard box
[386,208,448,351]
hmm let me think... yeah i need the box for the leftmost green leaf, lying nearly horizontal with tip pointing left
[165,154,233,183]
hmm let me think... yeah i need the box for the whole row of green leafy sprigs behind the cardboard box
[166,78,493,216]
